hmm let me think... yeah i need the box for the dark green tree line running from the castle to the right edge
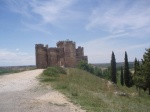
[78,48,150,95]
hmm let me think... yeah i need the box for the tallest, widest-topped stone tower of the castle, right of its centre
[57,40,76,67]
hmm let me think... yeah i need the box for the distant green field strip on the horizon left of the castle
[0,66,36,75]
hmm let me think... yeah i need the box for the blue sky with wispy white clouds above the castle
[0,0,150,66]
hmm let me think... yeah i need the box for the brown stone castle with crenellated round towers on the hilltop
[35,40,88,68]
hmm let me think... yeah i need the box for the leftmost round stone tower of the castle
[35,44,48,68]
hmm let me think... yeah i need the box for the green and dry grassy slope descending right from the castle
[39,69,150,112]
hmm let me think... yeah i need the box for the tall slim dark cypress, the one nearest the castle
[111,51,117,84]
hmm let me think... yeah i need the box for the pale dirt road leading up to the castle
[0,69,85,112]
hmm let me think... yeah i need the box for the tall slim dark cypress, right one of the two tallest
[124,51,130,87]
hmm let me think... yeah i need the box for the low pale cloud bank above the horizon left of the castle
[0,49,35,66]
